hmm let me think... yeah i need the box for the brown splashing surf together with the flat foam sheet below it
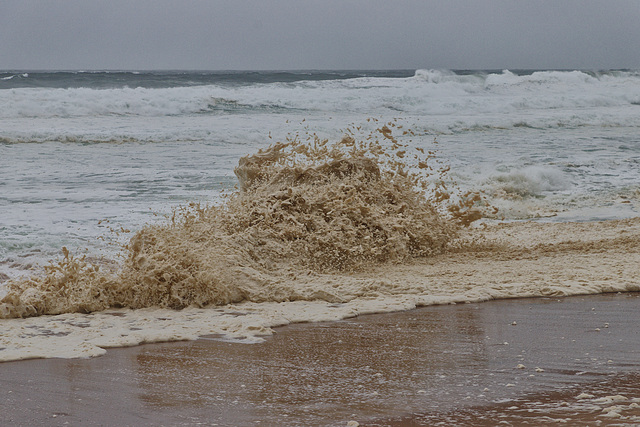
[0,120,640,360]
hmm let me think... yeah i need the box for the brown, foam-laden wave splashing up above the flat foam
[0,122,488,318]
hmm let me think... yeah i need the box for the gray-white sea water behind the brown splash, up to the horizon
[0,70,640,362]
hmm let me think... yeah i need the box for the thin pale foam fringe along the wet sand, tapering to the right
[0,285,636,361]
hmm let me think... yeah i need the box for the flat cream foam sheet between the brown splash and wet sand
[0,218,640,361]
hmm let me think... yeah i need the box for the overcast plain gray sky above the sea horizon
[0,0,640,70]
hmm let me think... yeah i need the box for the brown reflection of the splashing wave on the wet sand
[136,307,488,423]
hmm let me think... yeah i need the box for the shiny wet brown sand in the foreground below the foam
[0,293,640,426]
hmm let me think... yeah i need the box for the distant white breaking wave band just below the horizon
[0,70,640,129]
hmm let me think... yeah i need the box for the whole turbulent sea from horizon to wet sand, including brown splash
[0,70,640,359]
